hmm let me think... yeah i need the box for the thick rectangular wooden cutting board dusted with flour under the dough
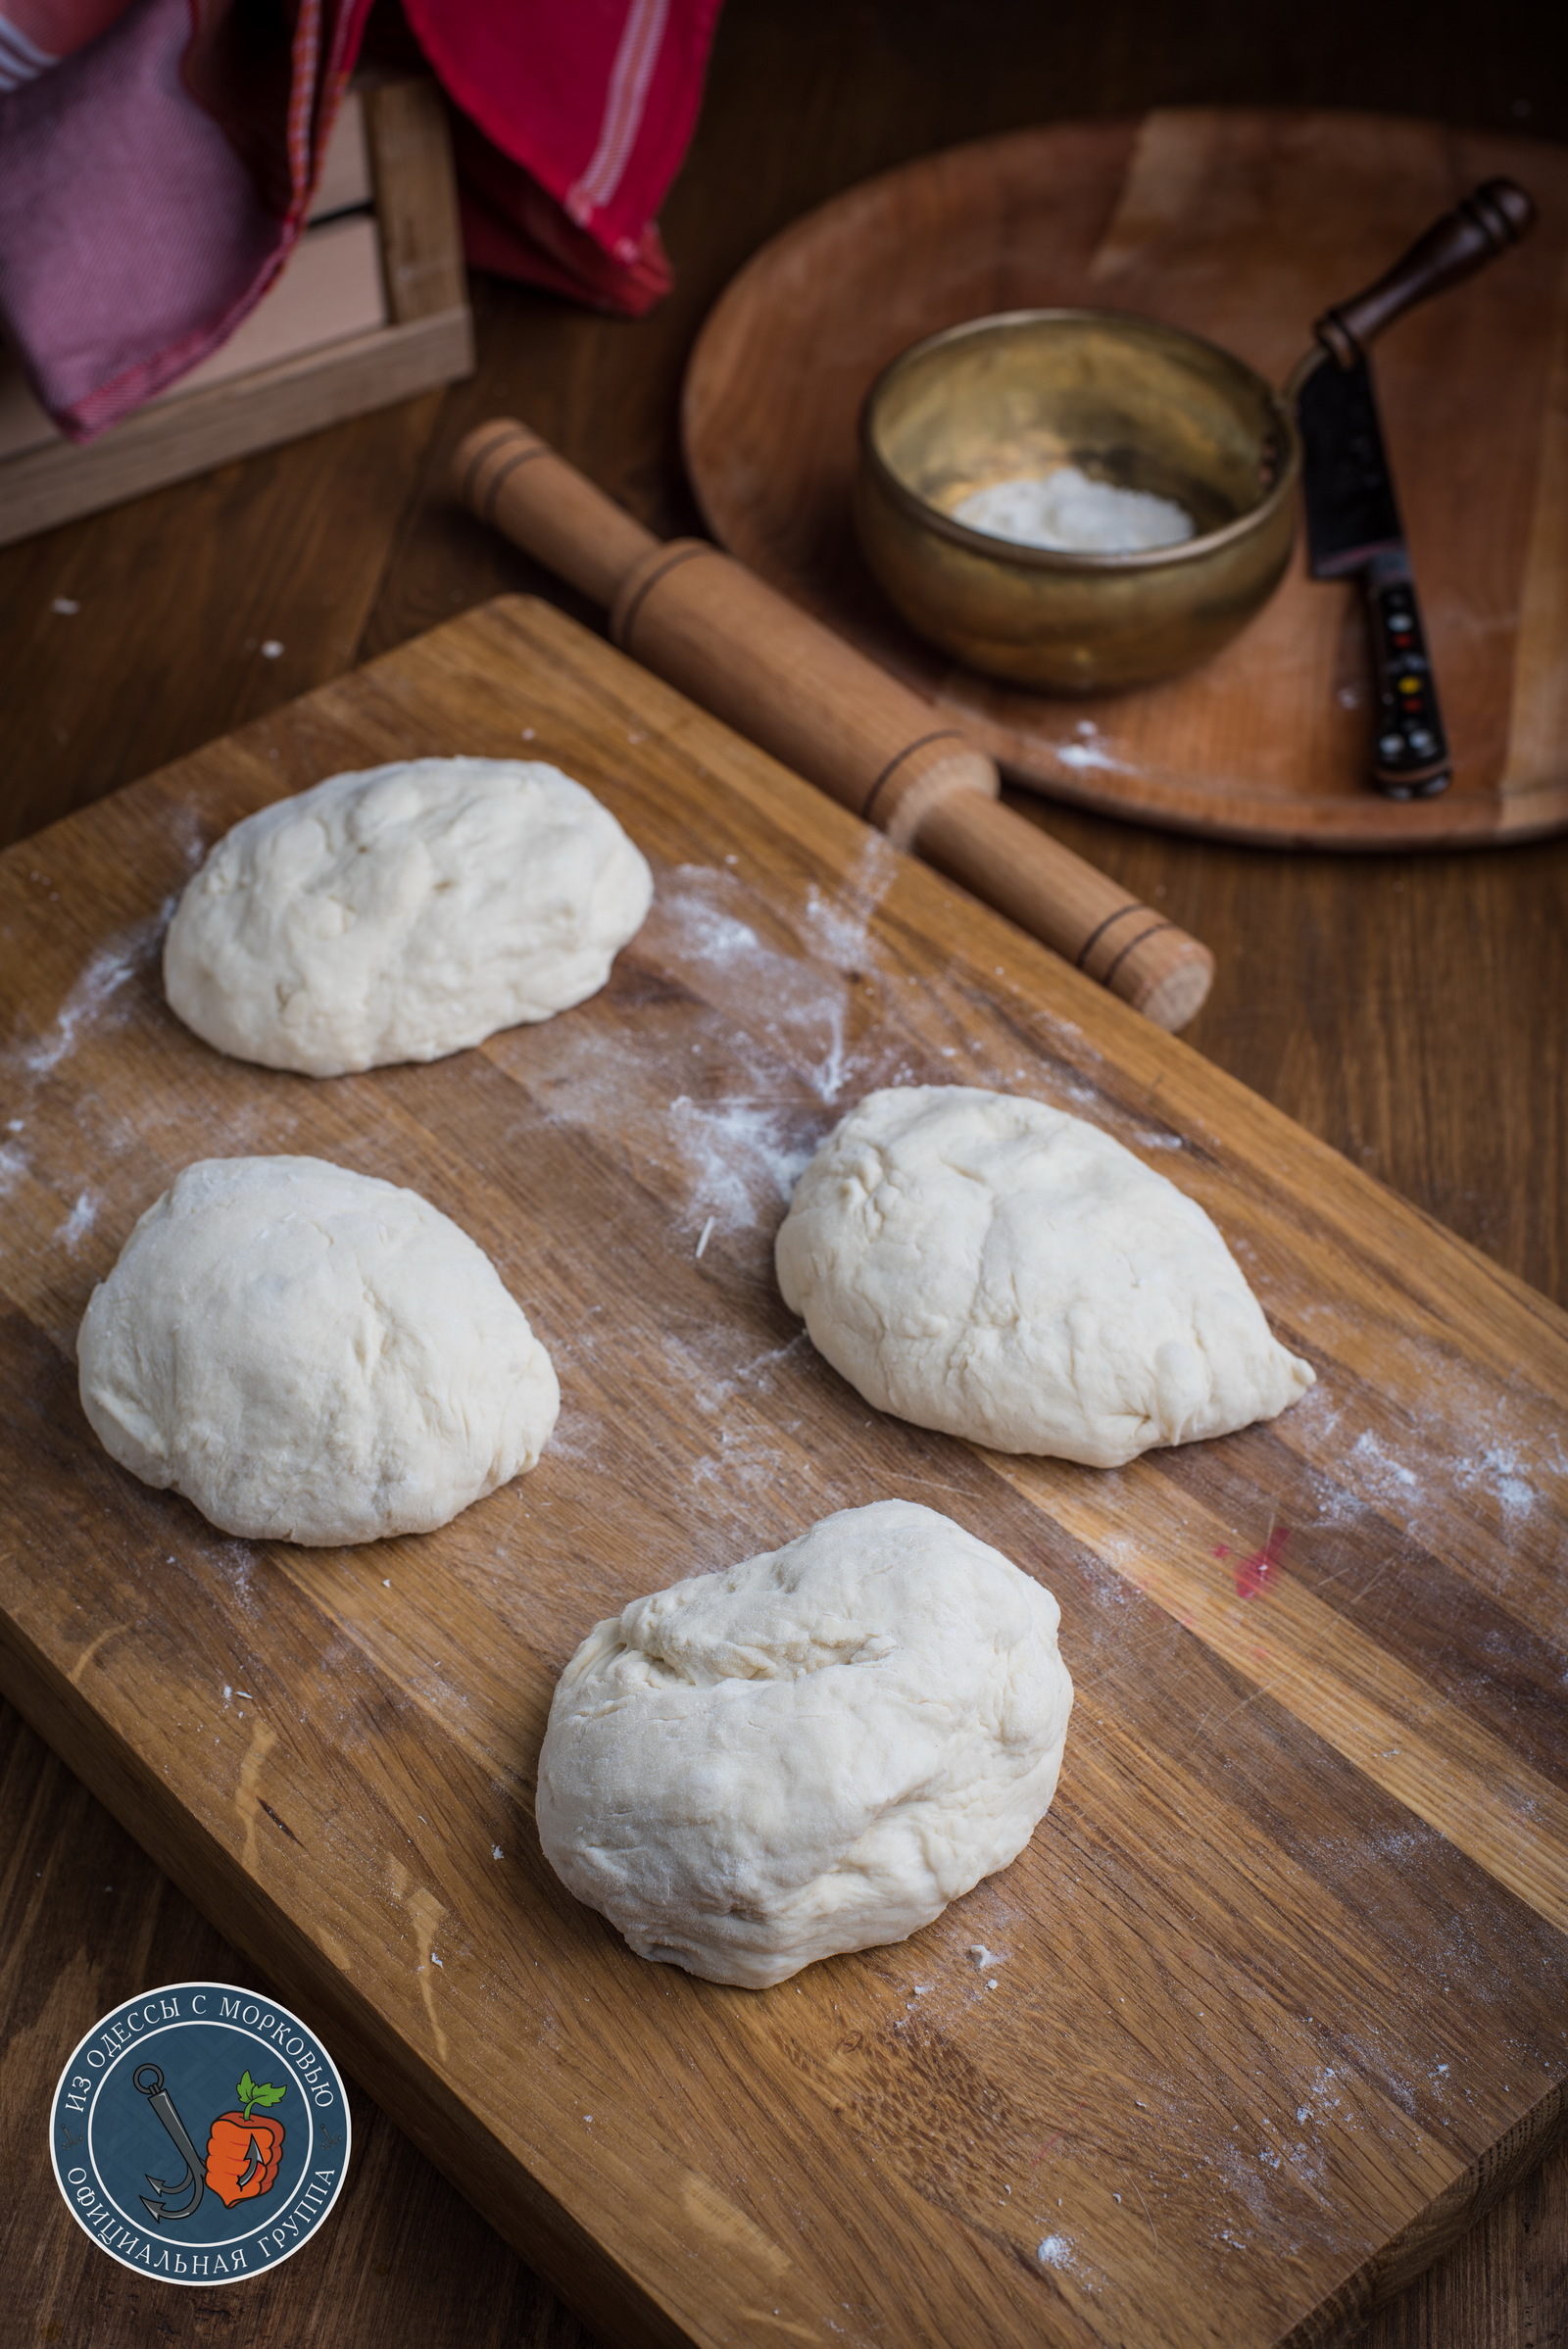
[0,599,1568,2349]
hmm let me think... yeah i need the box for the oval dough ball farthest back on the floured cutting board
[165,759,653,1076]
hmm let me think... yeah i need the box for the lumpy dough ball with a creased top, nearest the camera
[538,1501,1073,1989]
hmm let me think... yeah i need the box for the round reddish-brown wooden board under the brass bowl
[685,108,1568,848]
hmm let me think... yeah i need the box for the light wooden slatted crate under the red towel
[0,77,474,545]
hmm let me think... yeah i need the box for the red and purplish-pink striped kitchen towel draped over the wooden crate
[0,0,720,439]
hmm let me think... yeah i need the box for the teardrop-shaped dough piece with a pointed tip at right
[774,1085,1314,1468]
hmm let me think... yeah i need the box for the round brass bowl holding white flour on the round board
[855,310,1300,693]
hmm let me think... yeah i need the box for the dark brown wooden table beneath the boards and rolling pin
[0,0,1568,2349]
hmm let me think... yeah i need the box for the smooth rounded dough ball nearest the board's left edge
[77,1158,561,1543]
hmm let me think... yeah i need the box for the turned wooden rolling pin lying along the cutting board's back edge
[453,418,1213,1029]
